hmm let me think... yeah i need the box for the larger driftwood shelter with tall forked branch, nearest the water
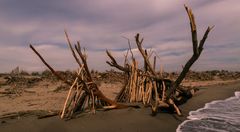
[106,6,212,115]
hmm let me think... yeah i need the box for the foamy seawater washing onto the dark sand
[176,91,240,132]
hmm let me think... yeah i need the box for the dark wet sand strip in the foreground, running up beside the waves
[0,81,240,132]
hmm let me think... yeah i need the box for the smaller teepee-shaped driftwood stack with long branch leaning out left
[30,31,138,118]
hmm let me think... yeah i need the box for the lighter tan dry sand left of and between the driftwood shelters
[0,81,122,116]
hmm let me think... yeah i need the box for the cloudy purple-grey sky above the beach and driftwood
[0,0,240,72]
